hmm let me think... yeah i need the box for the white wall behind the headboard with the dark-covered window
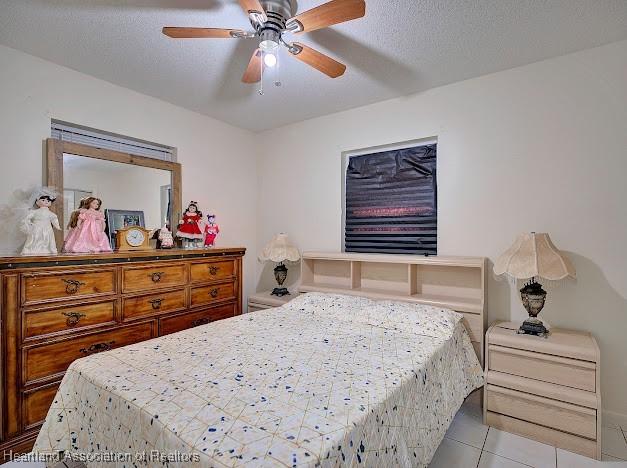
[258,42,627,417]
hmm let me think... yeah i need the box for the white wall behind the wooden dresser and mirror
[0,46,257,304]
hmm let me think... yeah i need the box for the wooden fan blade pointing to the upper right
[287,0,366,32]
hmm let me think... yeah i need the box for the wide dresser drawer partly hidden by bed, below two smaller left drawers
[22,322,153,384]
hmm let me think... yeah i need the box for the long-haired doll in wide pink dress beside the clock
[63,197,111,253]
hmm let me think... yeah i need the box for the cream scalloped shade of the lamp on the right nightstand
[494,232,576,281]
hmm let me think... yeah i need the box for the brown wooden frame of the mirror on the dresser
[46,138,183,251]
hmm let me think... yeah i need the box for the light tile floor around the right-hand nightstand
[429,391,627,468]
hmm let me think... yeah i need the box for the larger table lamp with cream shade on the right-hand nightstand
[494,232,575,337]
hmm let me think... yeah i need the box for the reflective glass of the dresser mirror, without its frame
[63,153,172,241]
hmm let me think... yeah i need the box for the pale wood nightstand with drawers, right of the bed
[483,322,601,460]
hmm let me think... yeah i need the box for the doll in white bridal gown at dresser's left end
[21,195,61,255]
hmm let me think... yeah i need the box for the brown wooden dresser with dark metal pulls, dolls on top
[0,248,245,453]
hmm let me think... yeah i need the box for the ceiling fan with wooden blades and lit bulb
[163,0,366,83]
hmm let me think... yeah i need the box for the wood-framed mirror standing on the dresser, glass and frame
[47,139,181,248]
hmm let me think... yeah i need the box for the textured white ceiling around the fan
[0,0,627,131]
